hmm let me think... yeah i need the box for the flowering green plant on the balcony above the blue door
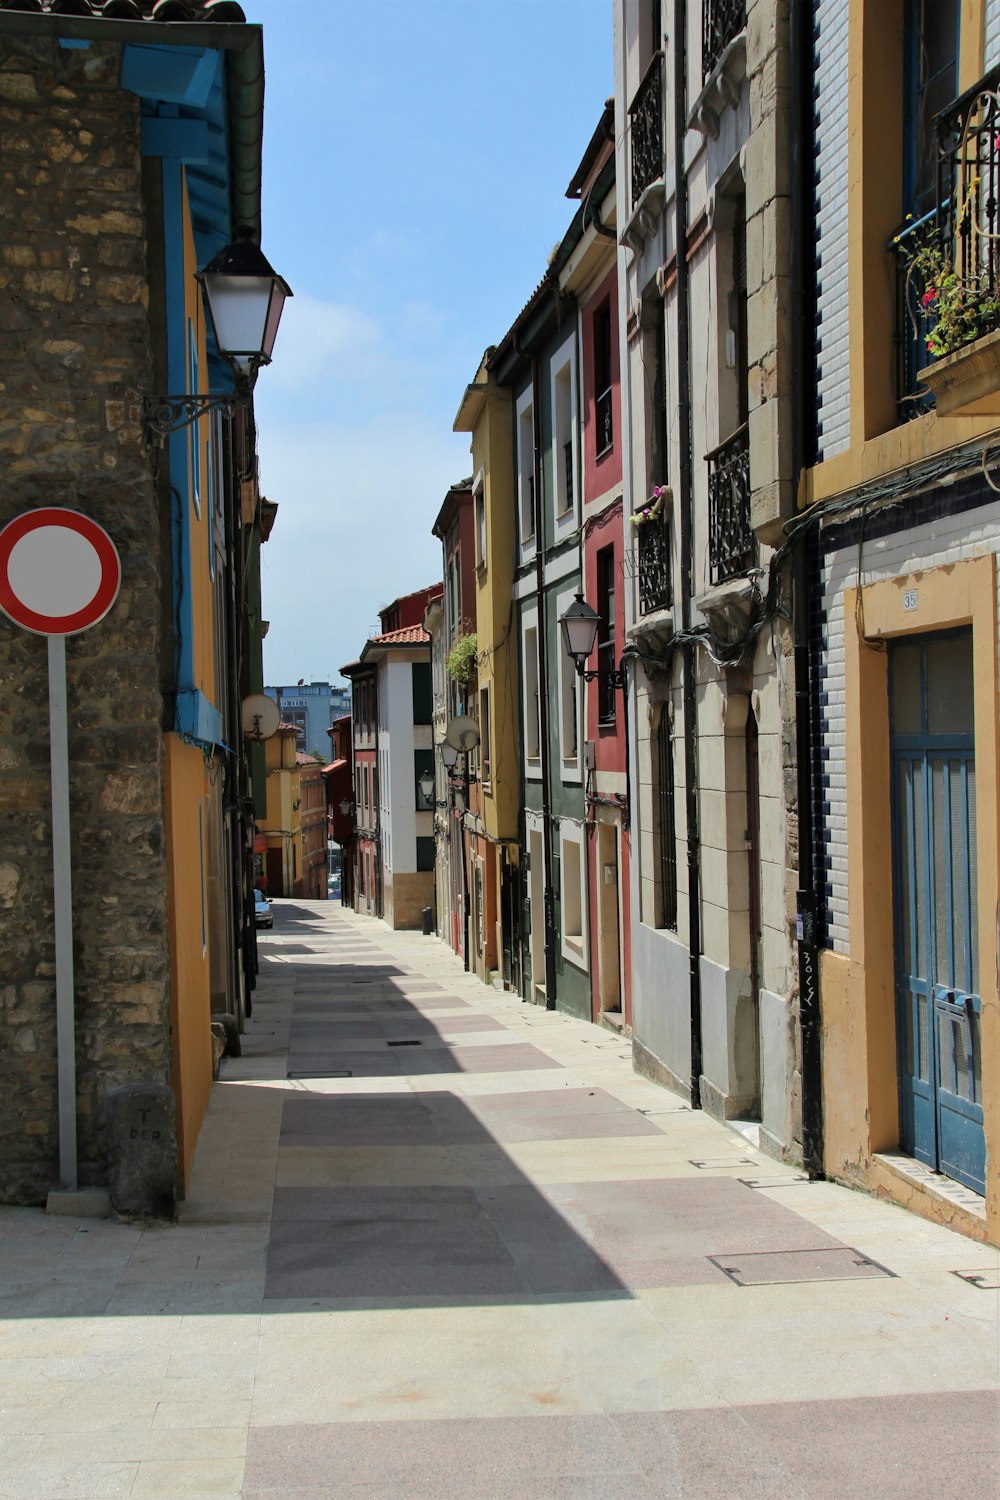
[894,177,1000,359]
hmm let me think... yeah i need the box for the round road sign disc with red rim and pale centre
[0,506,121,636]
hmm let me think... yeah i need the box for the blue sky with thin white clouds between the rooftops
[243,0,613,683]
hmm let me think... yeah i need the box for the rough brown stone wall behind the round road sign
[0,32,169,1202]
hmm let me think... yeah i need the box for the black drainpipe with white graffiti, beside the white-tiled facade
[789,5,823,1178]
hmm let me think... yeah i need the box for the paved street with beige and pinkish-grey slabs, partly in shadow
[0,902,1000,1500]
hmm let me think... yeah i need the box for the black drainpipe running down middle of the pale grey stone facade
[673,0,702,1110]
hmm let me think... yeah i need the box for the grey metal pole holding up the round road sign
[48,636,76,1188]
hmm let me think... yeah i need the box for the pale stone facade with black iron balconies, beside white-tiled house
[615,0,801,1157]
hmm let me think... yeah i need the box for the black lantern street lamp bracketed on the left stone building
[142,230,292,441]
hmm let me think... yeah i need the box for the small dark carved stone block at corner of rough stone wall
[105,1083,177,1220]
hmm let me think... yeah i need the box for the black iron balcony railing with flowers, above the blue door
[892,68,1000,419]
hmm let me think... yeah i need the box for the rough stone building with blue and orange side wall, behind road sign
[0,6,274,1203]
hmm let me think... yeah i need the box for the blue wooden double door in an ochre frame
[889,632,985,1193]
